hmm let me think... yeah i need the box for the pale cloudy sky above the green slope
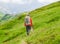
[0,0,59,14]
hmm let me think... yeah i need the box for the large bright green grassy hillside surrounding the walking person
[0,2,60,44]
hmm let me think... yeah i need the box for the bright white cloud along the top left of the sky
[0,0,32,4]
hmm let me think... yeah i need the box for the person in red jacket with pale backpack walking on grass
[24,14,32,35]
